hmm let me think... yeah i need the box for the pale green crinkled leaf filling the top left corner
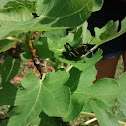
[0,0,62,39]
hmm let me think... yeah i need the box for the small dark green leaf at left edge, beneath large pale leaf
[0,40,17,53]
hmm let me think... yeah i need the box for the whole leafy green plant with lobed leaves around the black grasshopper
[0,0,126,126]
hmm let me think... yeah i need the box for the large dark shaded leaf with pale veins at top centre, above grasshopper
[37,0,94,27]
